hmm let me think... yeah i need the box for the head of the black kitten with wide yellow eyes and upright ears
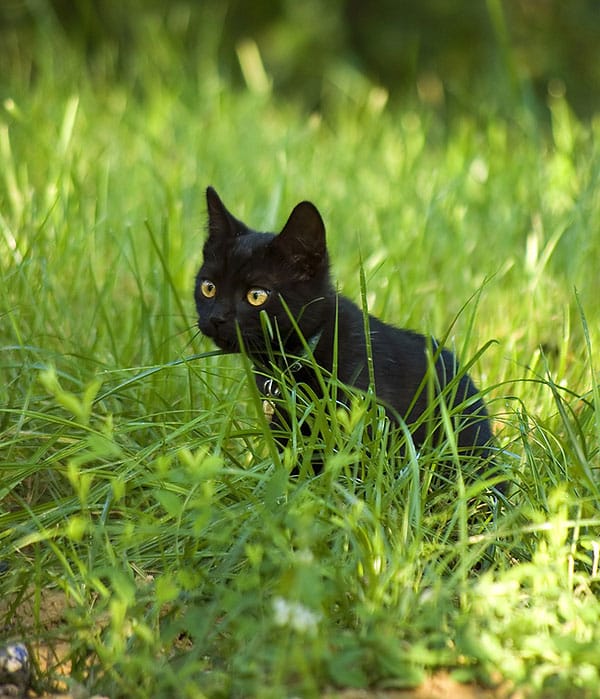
[195,187,334,356]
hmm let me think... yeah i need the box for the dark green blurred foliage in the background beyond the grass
[0,0,600,116]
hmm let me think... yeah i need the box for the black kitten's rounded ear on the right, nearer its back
[273,201,327,279]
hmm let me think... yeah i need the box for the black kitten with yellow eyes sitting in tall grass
[195,187,492,470]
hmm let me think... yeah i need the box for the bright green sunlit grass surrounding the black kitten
[0,10,600,697]
